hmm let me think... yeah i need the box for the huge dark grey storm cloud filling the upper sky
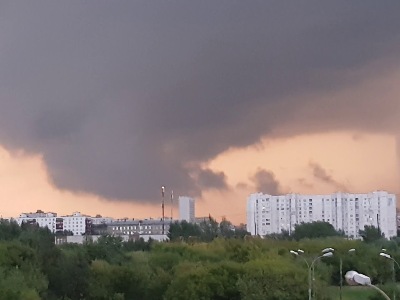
[0,0,400,201]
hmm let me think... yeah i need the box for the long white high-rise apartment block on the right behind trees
[247,191,397,238]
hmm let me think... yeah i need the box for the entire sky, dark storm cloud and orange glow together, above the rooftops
[0,0,400,223]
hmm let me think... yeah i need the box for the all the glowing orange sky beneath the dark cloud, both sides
[0,132,400,223]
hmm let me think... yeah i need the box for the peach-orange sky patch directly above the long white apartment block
[199,132,400,222]
